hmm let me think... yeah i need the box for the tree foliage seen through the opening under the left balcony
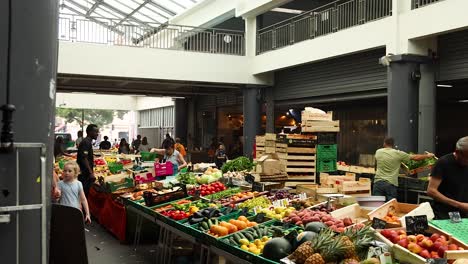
[56,107,128,127]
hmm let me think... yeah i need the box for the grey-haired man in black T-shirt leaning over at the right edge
[427,137,468,219]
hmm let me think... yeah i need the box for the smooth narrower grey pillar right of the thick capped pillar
[418,64,437,153]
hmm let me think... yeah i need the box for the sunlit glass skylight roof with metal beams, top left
[60,0,201,26]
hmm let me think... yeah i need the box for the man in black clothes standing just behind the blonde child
[76,124,99,195]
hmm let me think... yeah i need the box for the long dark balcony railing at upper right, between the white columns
[257,0,392,54]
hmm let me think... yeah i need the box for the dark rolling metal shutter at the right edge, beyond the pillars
[438,30,468,81]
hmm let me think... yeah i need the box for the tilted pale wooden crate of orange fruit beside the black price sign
[368,199,418,228]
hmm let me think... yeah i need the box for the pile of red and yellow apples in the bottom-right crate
[380,229,464,259]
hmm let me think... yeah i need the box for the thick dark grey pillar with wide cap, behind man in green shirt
[388,54,427,152]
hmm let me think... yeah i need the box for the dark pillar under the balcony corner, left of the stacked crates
[243,86,261,157]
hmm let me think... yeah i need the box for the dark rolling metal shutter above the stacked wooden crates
[274,49,387,101]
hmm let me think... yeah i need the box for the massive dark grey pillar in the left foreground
[0,0,58,264]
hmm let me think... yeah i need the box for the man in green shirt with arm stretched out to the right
[373,138,434,201]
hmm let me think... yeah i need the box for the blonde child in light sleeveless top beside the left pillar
[57,161,91,223]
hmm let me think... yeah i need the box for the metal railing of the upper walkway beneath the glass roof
[58,14,245,56]
